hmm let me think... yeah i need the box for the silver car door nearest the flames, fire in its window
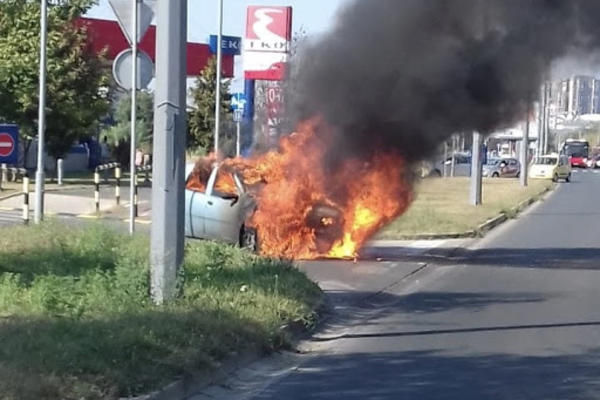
[204,168,244,244]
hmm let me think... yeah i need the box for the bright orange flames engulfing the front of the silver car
[197,119,412,259]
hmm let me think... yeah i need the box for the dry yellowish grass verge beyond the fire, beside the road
[377,178,552,239]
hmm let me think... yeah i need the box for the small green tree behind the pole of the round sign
[102,91,154,165]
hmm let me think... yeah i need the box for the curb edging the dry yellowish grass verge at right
[386,185,556,240]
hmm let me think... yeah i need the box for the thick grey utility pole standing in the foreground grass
[150,0,187,304]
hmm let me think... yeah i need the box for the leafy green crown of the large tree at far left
[0,0,109,158]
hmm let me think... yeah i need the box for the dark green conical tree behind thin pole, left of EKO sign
[188,57,233,154]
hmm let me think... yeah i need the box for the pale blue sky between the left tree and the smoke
[87,0,350,90]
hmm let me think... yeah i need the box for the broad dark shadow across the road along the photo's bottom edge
[257,350,600,400]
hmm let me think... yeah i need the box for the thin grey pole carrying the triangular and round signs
[129,0,140,235]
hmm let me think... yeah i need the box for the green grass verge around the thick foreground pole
[0,223,321,400]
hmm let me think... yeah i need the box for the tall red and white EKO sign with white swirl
[244,6,292,80]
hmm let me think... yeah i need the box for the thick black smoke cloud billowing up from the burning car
[288,0,600,161]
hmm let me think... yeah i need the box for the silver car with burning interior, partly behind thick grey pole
[185,165,258,251]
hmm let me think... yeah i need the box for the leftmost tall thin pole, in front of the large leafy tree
[34,0,48,224]
